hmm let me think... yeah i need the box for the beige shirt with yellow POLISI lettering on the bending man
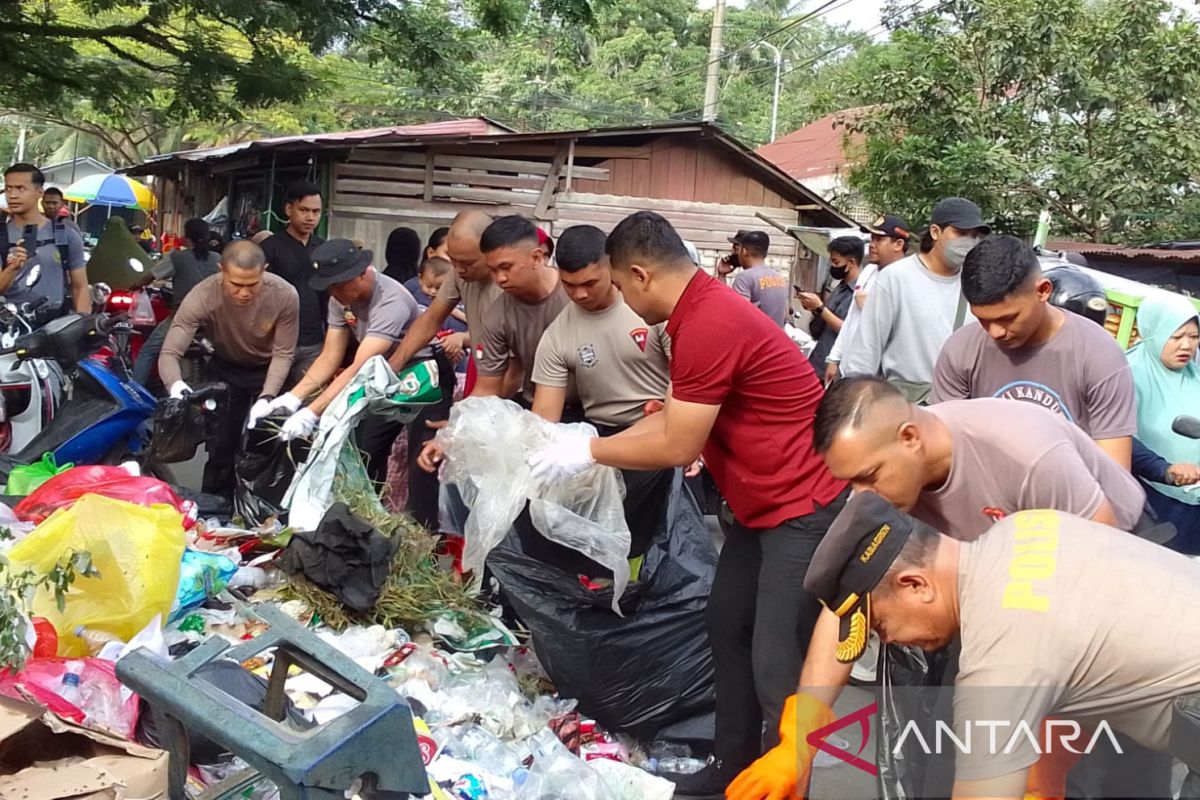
[943,511,1200,781]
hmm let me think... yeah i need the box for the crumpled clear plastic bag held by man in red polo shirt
[437,397,630,614]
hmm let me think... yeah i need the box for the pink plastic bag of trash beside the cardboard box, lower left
[0,658,138,740]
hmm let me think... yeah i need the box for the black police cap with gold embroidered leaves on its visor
[804,492,931,663]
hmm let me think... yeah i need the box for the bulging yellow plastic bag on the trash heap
[8,494,184,656]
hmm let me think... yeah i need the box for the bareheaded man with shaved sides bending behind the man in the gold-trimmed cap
[734,377,1145,800]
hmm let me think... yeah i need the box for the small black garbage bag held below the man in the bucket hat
[233,413,310,528]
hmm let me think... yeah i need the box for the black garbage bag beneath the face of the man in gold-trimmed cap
[875,640,960,800]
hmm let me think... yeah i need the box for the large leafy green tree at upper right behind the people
[851,0,1200,241]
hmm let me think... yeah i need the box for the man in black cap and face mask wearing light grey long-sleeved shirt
[841,197,991,401]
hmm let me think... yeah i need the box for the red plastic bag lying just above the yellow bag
[13,464,196,528]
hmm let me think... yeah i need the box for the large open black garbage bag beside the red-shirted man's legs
[487,475,716,740]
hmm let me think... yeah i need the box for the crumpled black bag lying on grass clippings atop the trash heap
[280,503,400,612]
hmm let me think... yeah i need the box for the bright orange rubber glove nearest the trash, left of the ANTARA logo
[725,692,834,800]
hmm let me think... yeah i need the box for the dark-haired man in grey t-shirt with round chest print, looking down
[932,236,1138,469]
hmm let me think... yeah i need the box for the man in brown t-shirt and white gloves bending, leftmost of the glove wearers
[158,241,300,497]
